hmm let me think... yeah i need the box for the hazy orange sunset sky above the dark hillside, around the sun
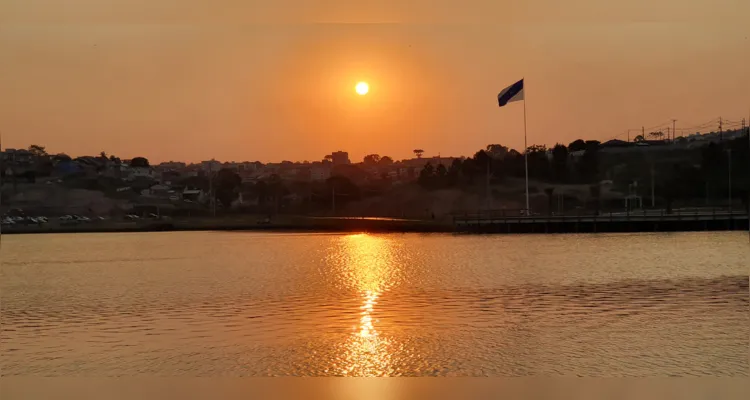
[0,0,750,162]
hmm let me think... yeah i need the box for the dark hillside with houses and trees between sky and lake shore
[0,123,750,224]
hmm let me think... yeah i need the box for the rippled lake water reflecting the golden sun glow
[0,232,750,377]
